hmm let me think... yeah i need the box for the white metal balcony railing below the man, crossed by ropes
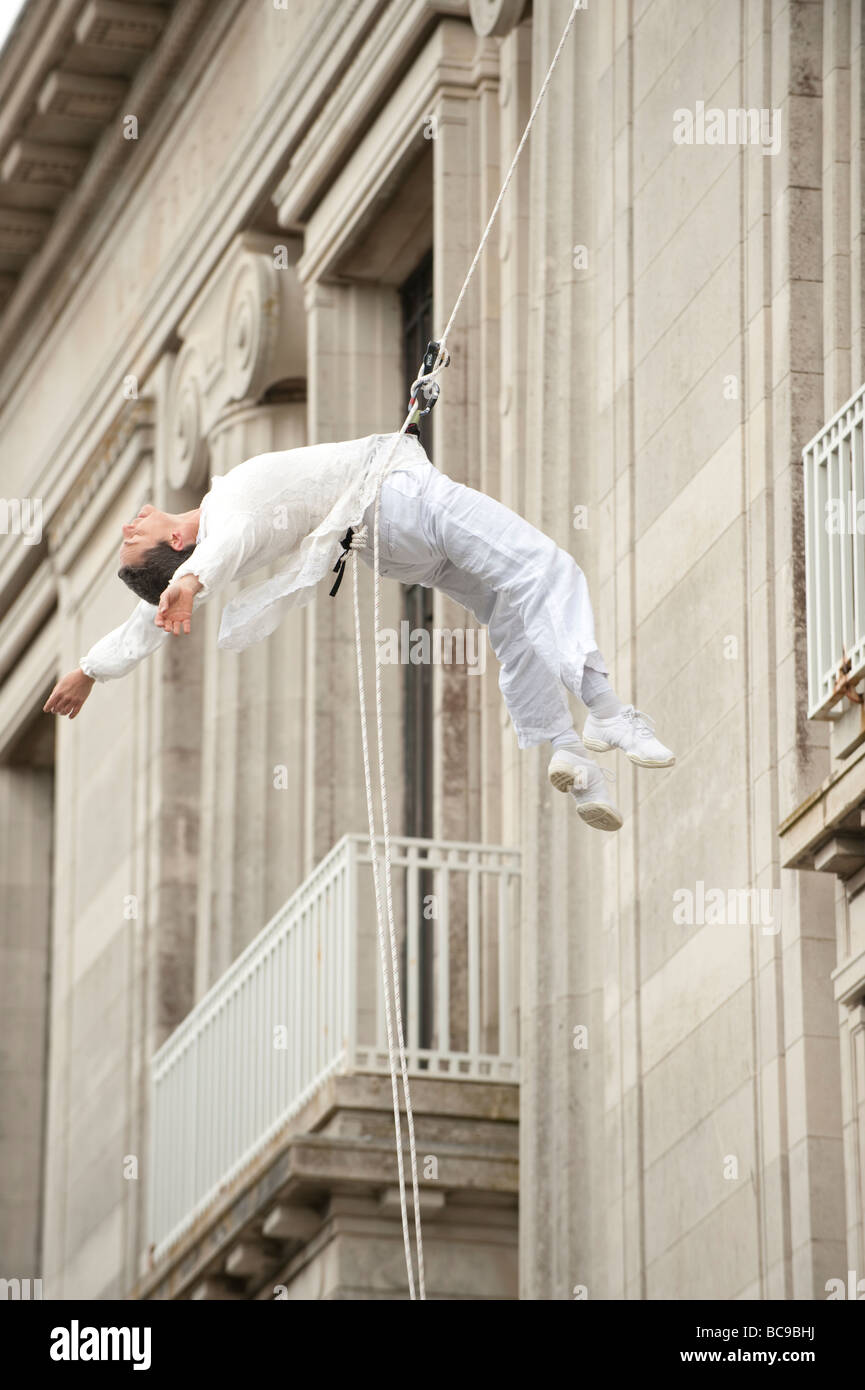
[149,835,520,1258]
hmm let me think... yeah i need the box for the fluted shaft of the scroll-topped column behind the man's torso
[196,400,312,995]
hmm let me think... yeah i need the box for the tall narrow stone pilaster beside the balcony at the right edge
[767,0,850,1300]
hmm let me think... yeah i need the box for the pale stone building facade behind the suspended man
[0,0,865,1300]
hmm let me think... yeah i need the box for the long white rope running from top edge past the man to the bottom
[346,0,581,1300]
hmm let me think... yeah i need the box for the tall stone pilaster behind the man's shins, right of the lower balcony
[506,0,606,1300]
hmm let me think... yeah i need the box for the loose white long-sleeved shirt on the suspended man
[79,434,428,681]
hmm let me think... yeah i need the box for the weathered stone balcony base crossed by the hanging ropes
[129,1074,519,1300]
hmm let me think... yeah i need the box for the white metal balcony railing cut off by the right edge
[802,386,865,719]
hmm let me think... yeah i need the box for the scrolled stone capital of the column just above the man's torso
[165,232,306,488]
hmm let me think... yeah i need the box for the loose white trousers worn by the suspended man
[357,463,608,748]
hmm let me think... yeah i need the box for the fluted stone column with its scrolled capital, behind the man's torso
[157,232,306,998]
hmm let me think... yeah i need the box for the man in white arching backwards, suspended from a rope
[45,427,674,830]
